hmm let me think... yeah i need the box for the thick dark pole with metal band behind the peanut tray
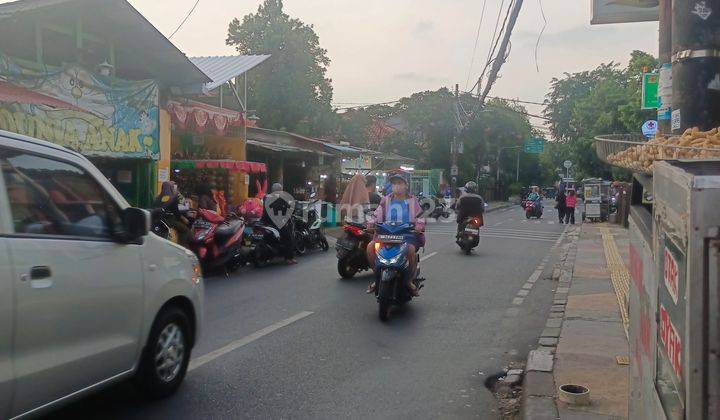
[671,0,720,134]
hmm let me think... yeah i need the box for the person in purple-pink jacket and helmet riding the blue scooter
[367,173,425,296]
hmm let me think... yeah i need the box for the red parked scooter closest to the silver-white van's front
[190,209,246,273]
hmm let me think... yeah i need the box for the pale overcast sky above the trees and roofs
[130,0,657,120]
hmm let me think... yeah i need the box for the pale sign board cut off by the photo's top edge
[590,0,660,25]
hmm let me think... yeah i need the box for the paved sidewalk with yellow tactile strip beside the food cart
[523,224,628,419]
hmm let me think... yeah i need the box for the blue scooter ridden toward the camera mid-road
[375,222,425,321]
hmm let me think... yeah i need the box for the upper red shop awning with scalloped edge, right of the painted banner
[167,100,245,136]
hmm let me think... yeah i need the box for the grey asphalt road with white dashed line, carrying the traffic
[47,205,564,419]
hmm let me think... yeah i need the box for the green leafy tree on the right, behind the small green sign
[541,51,657,178]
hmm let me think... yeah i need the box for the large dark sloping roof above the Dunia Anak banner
[0,0,210,86]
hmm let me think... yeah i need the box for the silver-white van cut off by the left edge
[0,131,203,418]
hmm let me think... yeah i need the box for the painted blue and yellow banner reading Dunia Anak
[0,54,160,160]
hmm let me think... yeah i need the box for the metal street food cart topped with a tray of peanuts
[596,129,720,419]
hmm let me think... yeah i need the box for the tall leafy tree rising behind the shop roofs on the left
[226,0,337,135]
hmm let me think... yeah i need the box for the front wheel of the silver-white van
[135,306,192,399]
